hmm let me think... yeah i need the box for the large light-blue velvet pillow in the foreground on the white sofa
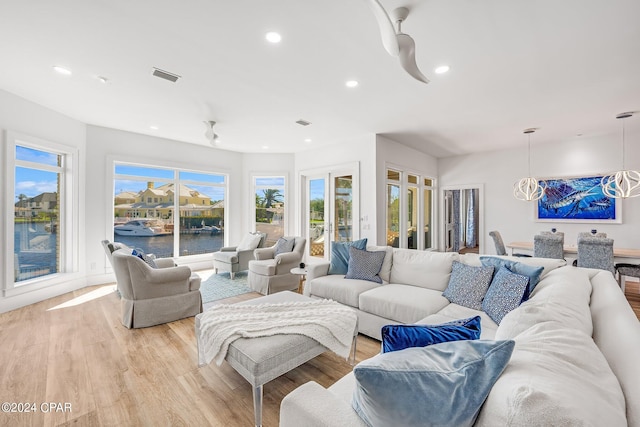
[351,340,515,427]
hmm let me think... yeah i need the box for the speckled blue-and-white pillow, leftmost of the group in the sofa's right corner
[442,261,494,310]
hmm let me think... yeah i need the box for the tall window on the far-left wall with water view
[5,132,77,289]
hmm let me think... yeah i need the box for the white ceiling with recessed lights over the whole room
[0,0,640,157]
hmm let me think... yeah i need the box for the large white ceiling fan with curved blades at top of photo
[366,0,429,83]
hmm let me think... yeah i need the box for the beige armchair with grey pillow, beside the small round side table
[248,236,307,295]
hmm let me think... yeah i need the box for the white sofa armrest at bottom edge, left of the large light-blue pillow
[280,381,366,427]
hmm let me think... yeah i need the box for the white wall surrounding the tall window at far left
[0,90,86,312]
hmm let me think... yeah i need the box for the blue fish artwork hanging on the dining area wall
[538,176,618,221]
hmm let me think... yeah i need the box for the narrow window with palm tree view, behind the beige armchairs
[253,176,286,246]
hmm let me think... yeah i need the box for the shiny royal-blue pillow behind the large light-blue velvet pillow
[382,316,480,353]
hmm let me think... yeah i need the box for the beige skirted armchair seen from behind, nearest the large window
[111,249,202,328]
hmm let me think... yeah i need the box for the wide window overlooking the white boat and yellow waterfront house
[113,162,227,258]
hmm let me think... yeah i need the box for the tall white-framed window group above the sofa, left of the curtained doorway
[386,169,433,249]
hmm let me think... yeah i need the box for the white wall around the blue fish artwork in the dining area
[438,130,640,253]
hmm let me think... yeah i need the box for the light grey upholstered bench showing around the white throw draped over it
[195,291,358,426]
